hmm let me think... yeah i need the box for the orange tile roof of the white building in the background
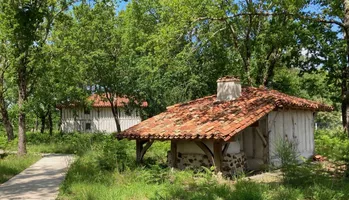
[88,94,148,108]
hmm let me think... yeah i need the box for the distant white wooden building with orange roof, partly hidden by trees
[59,94,147,133]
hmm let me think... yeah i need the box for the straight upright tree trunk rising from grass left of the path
[17,65,27,156]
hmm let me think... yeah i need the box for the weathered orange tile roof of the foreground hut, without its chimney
[117,87,333,140]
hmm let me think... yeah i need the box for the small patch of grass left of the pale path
[0,154,41,183]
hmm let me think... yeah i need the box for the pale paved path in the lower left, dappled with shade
[0,154,74,200]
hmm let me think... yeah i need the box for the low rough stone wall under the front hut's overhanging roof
[167,152,246,175]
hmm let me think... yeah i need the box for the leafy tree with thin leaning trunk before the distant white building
[54,1,133,132]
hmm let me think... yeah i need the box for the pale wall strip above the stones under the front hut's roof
[177,141,240,154]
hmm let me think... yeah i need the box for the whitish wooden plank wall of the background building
[61,108,141,133]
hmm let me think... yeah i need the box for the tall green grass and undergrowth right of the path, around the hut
[0,131,349,200]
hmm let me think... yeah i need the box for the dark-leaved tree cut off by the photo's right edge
[284,0,349,134]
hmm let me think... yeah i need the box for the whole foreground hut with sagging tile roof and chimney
[117,77,333,174]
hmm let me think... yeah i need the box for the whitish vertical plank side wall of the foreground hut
[268,110,314,164]
